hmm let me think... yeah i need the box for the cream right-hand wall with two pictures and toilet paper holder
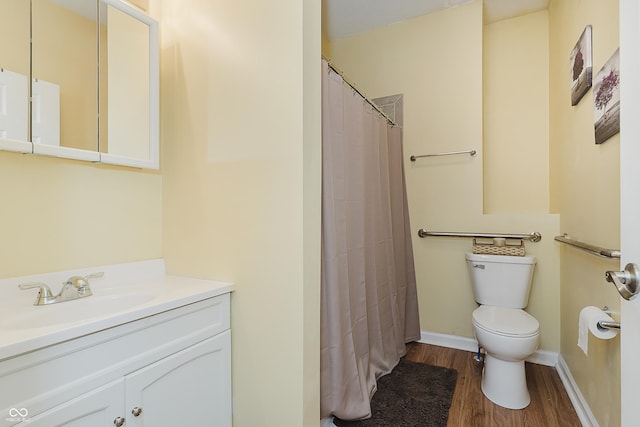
[549,0,621,426]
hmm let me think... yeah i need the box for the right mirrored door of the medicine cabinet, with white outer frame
[99,0,158,168]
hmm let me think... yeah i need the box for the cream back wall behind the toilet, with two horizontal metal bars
[324,1,560,351]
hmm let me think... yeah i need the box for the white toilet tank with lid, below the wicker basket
[465,253,536,308]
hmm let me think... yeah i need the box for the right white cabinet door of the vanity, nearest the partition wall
[125,331,231,427]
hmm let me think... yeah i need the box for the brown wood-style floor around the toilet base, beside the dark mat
[406,343,581,427]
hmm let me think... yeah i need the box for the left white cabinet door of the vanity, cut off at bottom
[19,379,125,427]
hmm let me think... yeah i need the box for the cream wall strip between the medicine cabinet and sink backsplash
[0,152,162,278]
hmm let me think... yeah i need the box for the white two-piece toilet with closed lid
[465,253,540,409]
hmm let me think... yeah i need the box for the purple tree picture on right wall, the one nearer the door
[593,49,620,144]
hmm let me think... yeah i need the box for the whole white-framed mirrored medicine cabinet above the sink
[0,0,159,169]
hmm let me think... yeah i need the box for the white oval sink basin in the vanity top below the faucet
[0,291,155,330]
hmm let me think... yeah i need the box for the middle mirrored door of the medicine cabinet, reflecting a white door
[31,0,99,161]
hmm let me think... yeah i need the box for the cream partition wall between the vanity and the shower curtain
[160,0,321,427]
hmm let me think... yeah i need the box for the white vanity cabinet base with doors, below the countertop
[0,293,231,427]
